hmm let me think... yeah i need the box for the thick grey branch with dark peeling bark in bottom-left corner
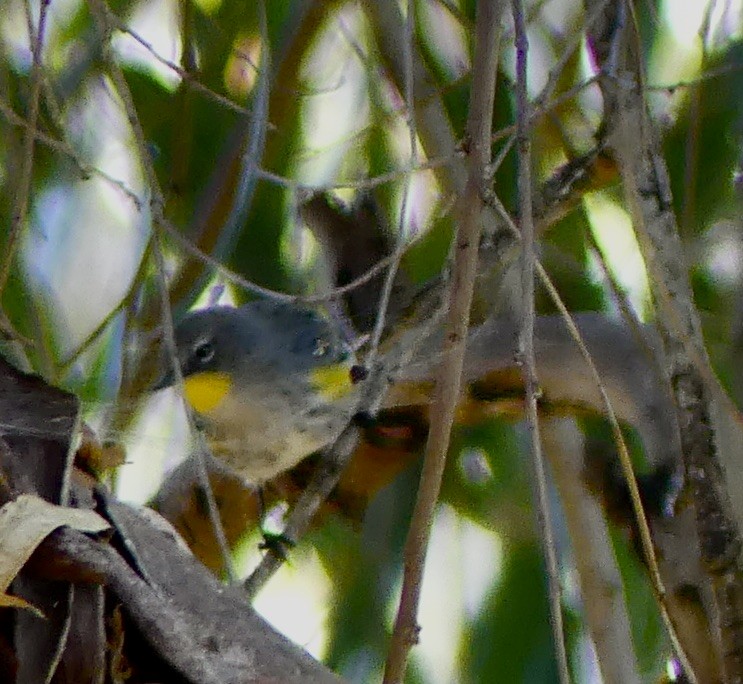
[0,352,338,684]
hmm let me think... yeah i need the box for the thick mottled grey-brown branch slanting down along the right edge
[590,3,743,681]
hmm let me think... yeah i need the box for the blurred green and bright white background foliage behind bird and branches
[0,0,743,682]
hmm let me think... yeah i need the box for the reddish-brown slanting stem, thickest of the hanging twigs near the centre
[384,0,503,684]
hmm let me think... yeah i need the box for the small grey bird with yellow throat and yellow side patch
[154,299,364,485]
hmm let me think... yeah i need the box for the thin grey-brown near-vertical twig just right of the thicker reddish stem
[513,0,570,684]
